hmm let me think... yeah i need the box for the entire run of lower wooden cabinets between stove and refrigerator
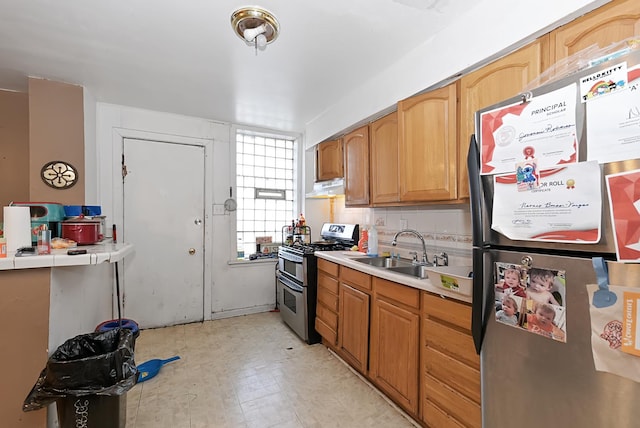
[315,259,482,428]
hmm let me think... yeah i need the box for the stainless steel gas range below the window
[276,223,360,344]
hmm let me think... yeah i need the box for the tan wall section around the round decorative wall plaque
[28,78,85,205]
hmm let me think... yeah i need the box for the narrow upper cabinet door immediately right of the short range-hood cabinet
[343,126,369,206]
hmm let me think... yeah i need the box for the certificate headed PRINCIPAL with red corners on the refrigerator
[479,83,578,175]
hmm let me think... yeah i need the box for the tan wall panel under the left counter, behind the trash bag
[0,268,51,428]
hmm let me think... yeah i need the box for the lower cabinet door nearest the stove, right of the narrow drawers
[338,283,369,373]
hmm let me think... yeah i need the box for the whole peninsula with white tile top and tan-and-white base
[0,242,134,428]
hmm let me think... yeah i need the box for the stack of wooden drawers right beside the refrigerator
[420,291,482,428]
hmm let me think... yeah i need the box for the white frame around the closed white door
[107,127,214,321]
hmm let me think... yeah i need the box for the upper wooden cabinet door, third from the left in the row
[369,111,399,205]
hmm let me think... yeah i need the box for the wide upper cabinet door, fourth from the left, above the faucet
[398,84,458,202]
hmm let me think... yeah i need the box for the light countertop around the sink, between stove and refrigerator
[315,251,471,303]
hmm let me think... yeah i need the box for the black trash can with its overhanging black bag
[22,328,138,428]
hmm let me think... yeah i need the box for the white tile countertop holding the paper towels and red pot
[0,242,133,270]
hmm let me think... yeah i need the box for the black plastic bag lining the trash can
[22,328,138,412]
